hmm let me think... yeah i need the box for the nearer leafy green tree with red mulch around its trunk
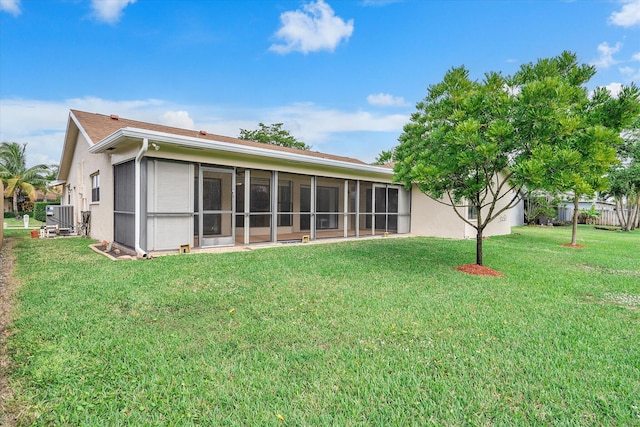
[394,67,526,265]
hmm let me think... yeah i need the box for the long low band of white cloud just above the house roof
[0,97,410,166]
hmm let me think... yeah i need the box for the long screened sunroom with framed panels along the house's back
[114,158,410,251]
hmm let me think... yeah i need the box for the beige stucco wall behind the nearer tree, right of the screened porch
[411,187,511,239]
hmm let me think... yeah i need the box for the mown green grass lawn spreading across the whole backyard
[7,227,640,426]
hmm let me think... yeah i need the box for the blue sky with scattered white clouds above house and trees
[0,0,640,164]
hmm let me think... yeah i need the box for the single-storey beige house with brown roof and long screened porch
[51,110,511,256]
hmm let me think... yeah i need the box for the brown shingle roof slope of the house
[71,110,366,165]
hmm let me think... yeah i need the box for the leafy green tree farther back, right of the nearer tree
[512,52,621,245]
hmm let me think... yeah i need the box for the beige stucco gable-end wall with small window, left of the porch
[61,134,113,242]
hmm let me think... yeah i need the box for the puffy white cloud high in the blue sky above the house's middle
[269,0,353,54]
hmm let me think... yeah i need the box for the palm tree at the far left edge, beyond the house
[0,142,49,217]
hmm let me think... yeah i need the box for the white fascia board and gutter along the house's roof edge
[89,127,393,175]
